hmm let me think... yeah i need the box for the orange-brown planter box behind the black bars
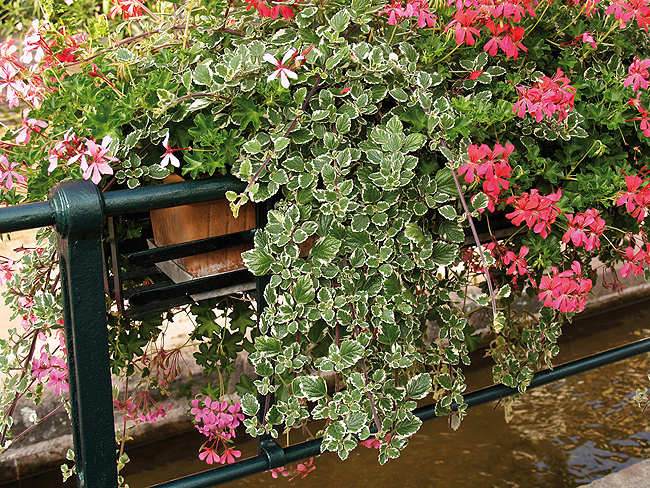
[150,174,255,300]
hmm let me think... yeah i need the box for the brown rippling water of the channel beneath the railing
[5,300,650,488]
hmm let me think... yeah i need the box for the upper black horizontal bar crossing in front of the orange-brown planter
[126,230,255,266]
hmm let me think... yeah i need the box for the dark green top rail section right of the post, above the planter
[103,176,246,216]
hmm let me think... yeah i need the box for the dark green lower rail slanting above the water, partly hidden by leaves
[152,339,650,488]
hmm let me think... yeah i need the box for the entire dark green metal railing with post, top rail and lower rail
[0,178,650,488]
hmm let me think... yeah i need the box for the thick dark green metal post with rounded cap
[50,180,117,488]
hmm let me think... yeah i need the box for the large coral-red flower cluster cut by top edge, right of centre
[445,0,536,59]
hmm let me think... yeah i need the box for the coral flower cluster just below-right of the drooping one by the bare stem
[506,188,562,238]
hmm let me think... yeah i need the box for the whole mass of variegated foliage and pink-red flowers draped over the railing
[0,0,650,476]
